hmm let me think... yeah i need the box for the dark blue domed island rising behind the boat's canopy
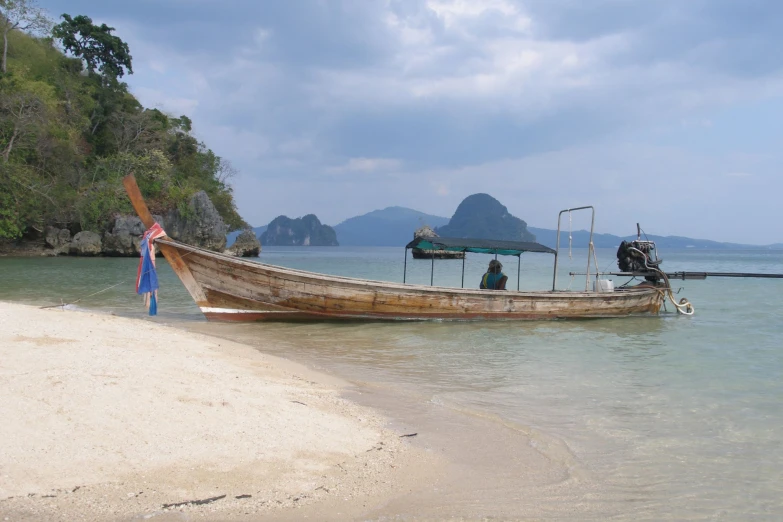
[436,194,536,241]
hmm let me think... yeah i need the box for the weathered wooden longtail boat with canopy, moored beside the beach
[123,175,666,321]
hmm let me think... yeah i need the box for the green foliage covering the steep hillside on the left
[0,20,246,238]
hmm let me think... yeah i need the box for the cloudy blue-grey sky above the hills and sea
[39,0,783,244]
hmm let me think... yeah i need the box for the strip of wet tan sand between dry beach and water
[180,321,620,520]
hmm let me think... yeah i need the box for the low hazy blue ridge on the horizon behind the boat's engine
[530,227,783,250]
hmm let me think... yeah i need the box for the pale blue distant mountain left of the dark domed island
[334,207,449,246]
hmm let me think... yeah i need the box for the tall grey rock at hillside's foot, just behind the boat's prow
[161,190,228,252]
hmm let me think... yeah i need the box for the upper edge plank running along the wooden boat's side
[155,237,661,299]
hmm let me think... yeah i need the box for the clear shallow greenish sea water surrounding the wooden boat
[0,247,783,520]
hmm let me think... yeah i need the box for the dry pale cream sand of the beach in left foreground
[0,303,438,521]
